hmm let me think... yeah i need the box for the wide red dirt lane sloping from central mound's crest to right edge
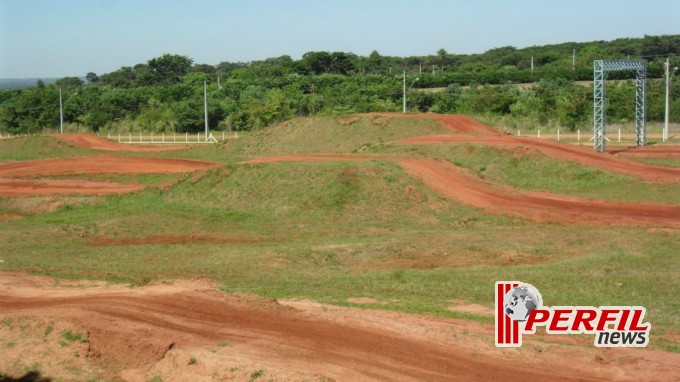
[399,158,680,226]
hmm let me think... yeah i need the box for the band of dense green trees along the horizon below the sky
[0,35,680,134]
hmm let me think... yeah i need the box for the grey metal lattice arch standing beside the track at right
[593,60,647,152]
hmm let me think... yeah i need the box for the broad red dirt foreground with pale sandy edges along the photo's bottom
[0,273,680,381]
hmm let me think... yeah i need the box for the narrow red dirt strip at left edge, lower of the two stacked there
[0,178,144,196]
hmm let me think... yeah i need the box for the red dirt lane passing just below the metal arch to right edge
[397,135,680,183]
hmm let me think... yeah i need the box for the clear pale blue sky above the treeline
[0,0,680,78]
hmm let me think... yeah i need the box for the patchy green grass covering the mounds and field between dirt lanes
[0,118,680,351]
